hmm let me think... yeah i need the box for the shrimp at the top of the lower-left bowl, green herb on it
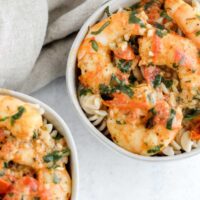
[0,95,42,140]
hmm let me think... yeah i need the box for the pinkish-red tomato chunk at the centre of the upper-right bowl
[142,66,160,83]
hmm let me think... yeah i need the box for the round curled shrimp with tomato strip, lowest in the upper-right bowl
[106,84,182,156]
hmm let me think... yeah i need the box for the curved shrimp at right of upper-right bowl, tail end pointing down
[139,32,200,104]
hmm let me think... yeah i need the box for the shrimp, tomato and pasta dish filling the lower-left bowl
[0,91,77,200]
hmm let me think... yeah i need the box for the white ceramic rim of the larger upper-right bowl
[66,0,200,161]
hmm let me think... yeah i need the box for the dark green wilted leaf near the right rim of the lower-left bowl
[43,149,70,163]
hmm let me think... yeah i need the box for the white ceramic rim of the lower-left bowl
[0,89,79,200]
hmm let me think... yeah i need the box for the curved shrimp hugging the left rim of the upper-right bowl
[78,11,147,93]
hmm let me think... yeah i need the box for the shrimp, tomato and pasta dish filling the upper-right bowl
[67,0,200,157]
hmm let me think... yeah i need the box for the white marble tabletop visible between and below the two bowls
[33,78,200,200]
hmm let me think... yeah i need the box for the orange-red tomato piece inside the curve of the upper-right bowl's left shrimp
[114,45,135,60]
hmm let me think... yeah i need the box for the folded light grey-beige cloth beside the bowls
[0,0,105,93]
